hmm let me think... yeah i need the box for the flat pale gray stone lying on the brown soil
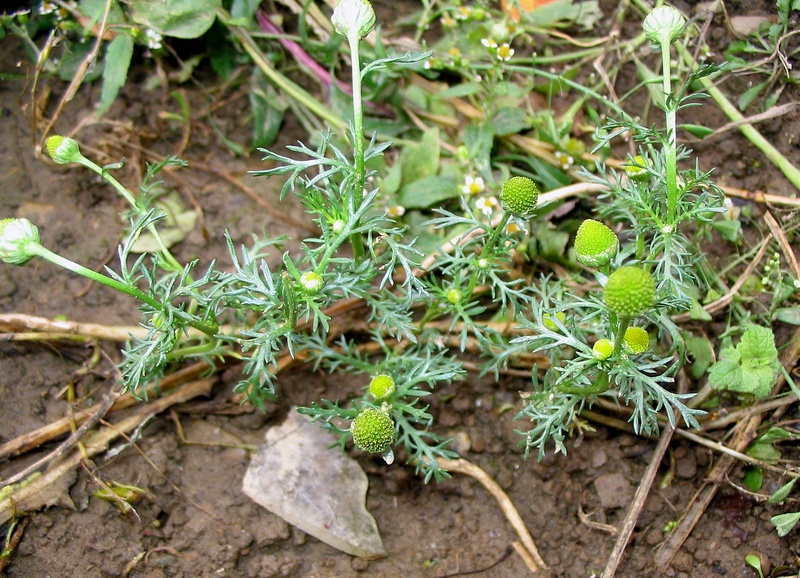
[242,408,387,558]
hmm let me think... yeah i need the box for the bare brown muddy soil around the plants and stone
[0,2,800,578]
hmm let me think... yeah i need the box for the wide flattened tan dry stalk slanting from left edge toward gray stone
[0,379,215,524]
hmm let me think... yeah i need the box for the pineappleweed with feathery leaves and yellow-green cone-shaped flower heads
[0,0,713,472]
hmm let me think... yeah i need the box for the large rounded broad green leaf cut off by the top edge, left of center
[133,0,222,38]
